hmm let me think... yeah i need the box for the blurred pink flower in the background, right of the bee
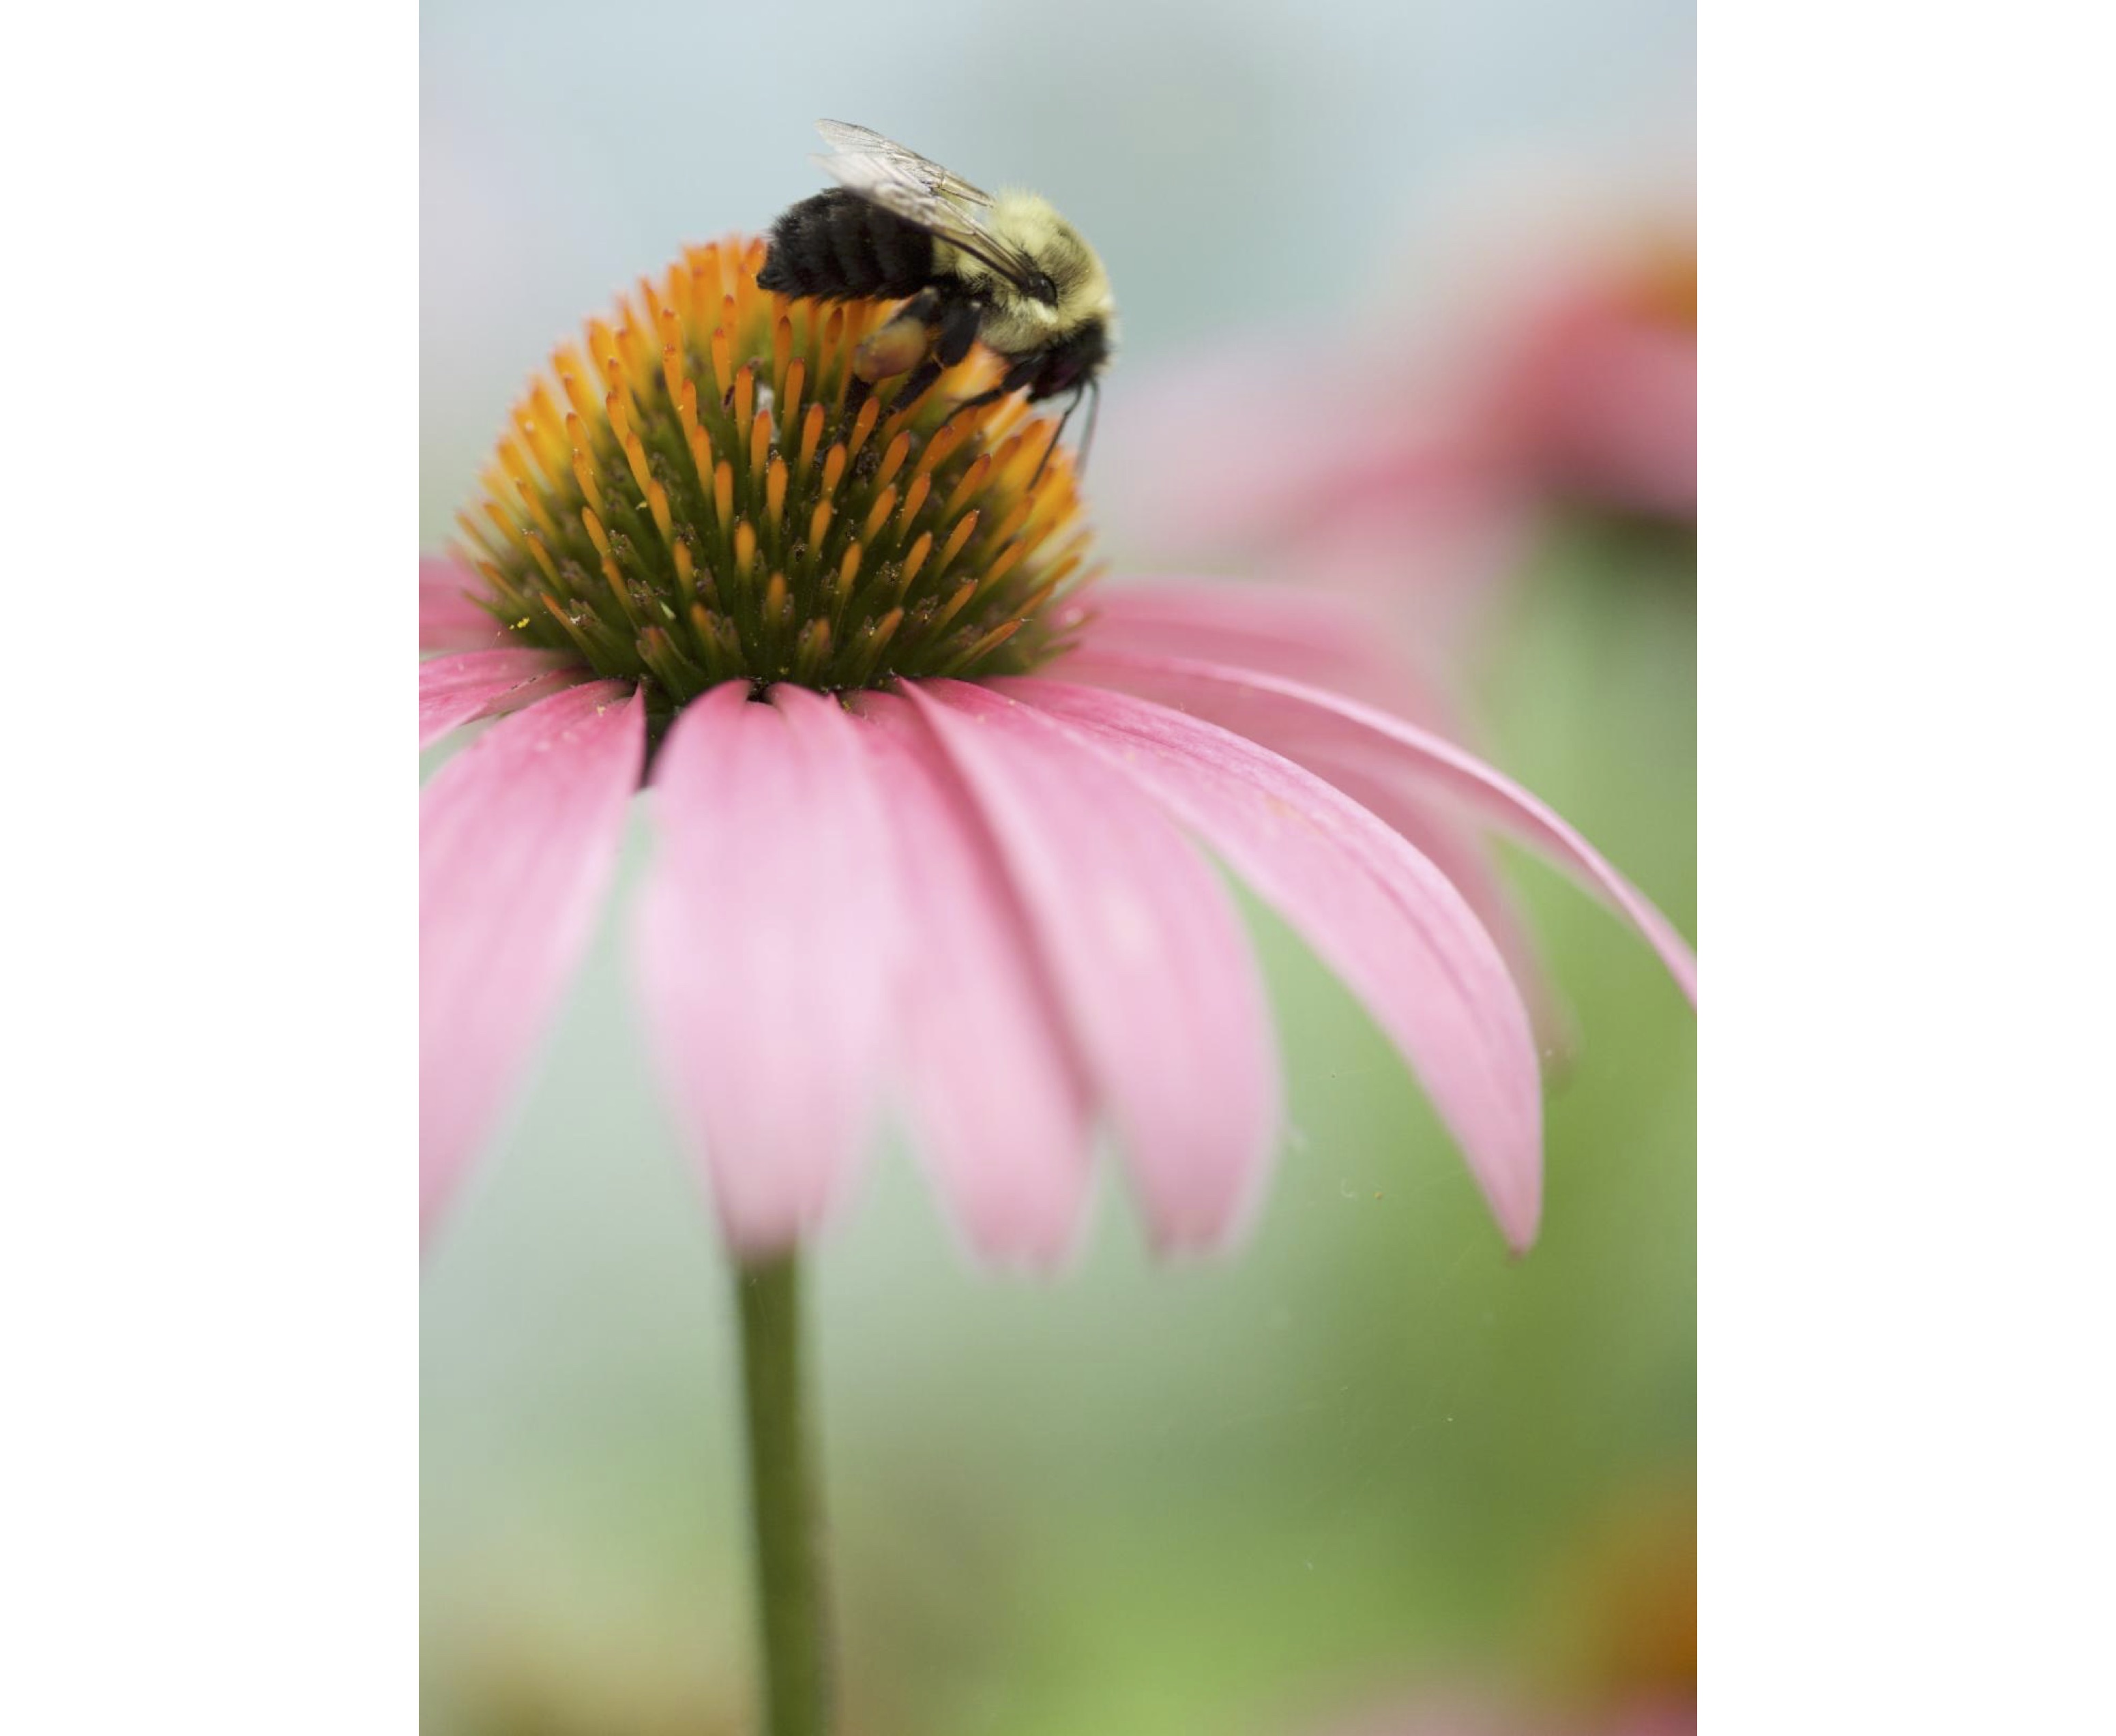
[1102,177,1697,648]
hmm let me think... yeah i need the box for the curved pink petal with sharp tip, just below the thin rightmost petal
[995,677,1542,1247]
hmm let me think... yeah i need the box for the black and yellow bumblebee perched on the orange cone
[758,121,1117,472]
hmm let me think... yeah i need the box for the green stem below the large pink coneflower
[736,1253,829,1736]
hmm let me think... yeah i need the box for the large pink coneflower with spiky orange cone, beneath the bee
[421,241,1693,1730]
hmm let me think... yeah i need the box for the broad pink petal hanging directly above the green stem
[632,681,904,1255]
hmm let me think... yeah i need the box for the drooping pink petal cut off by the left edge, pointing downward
[419,681,645,1228]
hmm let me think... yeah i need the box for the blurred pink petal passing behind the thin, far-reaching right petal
[1052,578,1572,1055]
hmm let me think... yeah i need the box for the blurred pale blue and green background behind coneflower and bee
[419,0,1697,1736]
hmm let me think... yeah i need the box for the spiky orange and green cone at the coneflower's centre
[457,237,1087,716]
